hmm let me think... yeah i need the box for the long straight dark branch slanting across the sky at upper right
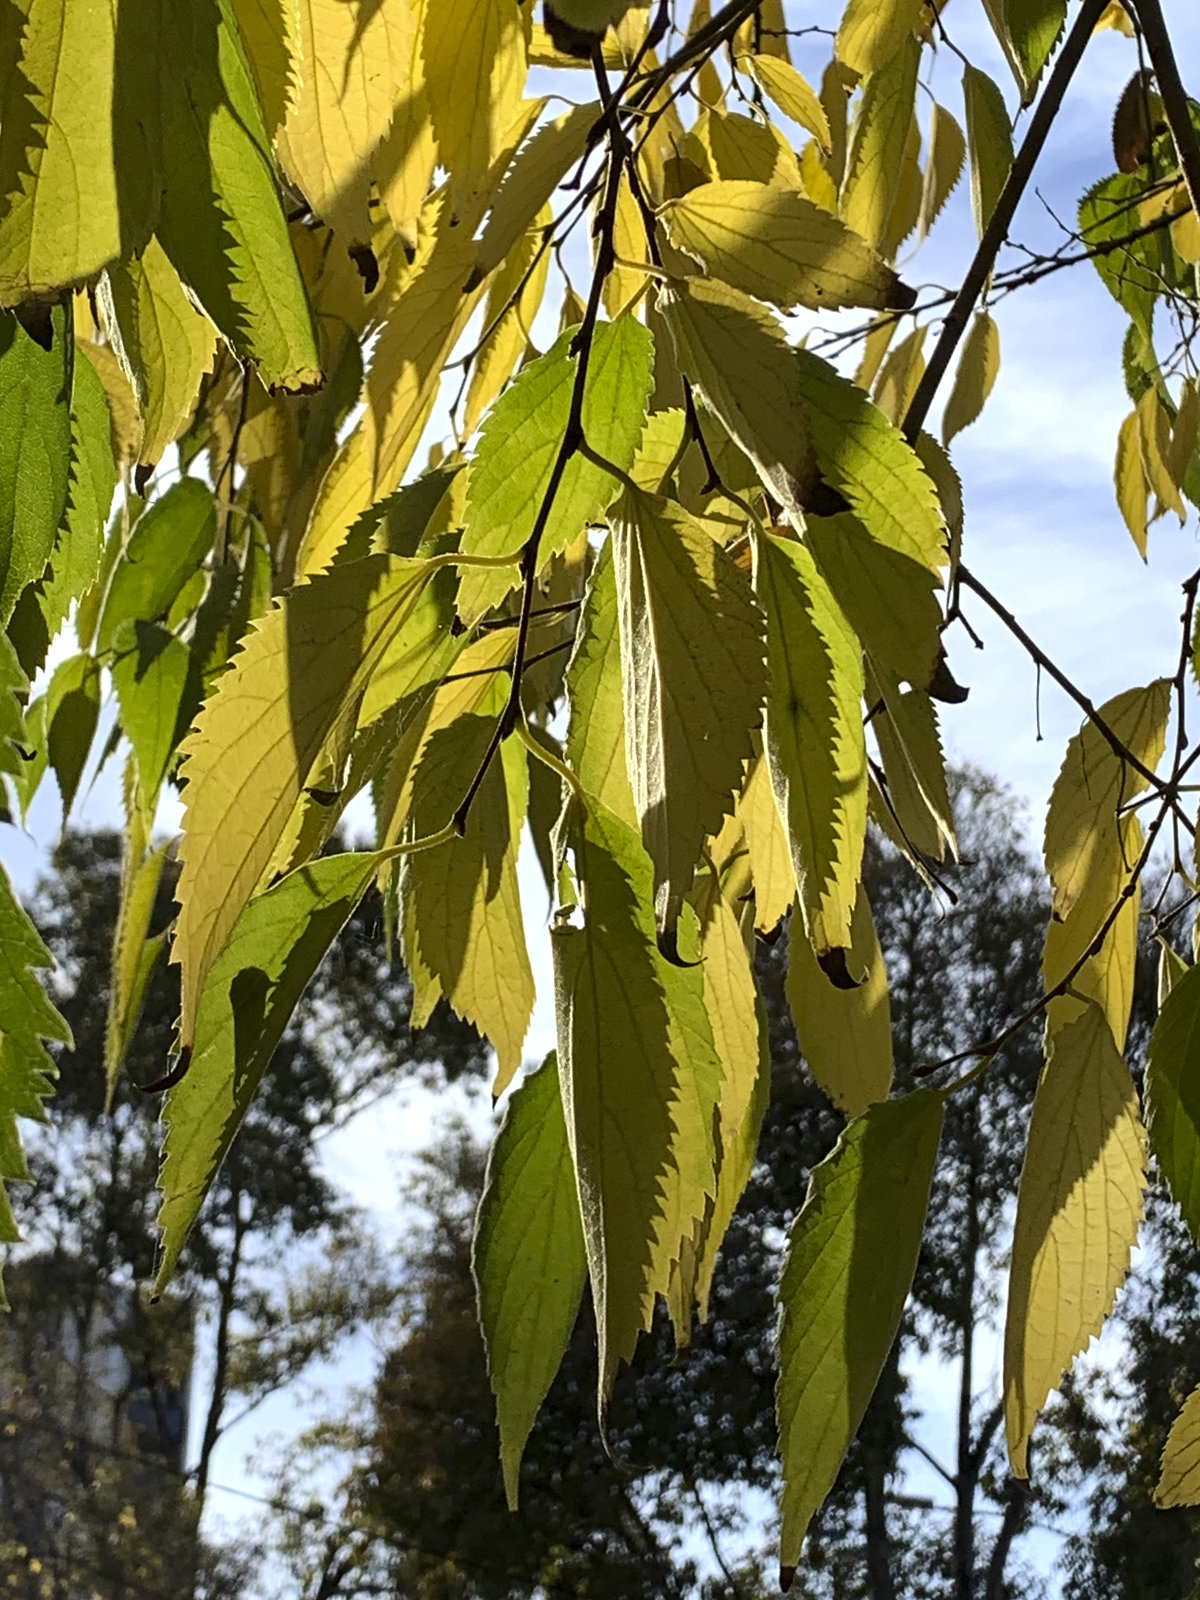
[904,0,1113,442]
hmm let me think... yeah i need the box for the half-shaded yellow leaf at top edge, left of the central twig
[421,0,538,210]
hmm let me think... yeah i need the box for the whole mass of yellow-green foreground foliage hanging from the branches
[0,0,1200,1587]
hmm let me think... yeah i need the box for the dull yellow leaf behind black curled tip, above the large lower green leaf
[787,885,891,1117]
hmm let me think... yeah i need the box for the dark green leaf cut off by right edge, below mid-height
[1146,966,1200,1238]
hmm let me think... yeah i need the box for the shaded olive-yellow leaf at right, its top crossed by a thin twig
[1045,678,1171,920]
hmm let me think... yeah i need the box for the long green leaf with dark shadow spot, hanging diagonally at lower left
[155,853,379,1294]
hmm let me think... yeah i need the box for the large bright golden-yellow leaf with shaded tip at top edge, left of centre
[275,0,416,246]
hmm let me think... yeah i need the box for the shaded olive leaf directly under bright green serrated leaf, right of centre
[805,512,942,688]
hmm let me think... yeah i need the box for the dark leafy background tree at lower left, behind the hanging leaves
[0,832,485,1600]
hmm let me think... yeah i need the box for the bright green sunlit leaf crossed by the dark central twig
[459,317,654,622]
